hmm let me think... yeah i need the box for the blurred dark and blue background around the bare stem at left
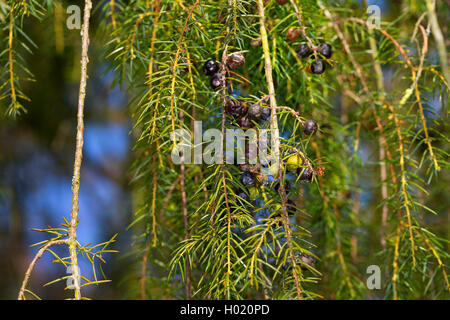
[0,0,449,299]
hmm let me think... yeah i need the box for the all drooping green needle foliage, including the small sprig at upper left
[0,0,450,299]
